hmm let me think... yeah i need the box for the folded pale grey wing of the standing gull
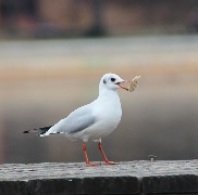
[48,107,96,134]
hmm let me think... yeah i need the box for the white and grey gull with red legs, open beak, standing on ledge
[23,73,129,166]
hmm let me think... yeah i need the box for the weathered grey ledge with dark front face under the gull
[0,160,198,195]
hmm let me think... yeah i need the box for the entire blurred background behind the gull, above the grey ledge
[0,0,198,163]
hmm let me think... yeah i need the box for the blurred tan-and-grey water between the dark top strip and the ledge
[0,36,198,163]
